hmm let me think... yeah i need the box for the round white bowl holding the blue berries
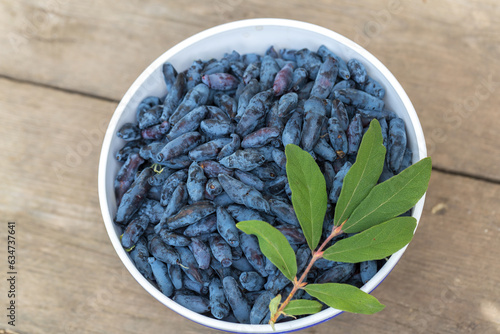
[99,19,427,333]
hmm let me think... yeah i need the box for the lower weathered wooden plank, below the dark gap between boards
[0,79,500,334]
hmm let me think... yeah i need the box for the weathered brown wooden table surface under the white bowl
[0,0,500,334]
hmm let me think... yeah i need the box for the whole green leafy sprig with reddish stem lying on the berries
[236,119,432,328]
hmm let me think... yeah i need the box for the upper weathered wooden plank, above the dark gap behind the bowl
[0,0,500,180]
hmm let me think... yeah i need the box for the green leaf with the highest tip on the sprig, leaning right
[334,119,385,226]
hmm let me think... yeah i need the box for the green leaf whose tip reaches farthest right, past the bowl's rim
[343,158,432,233]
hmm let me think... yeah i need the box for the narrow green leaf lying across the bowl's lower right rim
[304,283,385,314]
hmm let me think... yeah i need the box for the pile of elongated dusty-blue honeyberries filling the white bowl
[115,46,412,324]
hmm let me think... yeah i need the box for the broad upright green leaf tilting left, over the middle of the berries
[285,144,327,250]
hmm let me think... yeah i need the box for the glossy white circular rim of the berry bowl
[98,18,427,333]
